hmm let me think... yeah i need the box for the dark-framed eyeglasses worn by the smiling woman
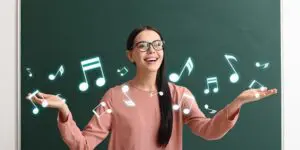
[134,40,165,52]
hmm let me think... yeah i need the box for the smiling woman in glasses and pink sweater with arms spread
[29,26,277,150]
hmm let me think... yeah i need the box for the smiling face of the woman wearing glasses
[128,30,164,72]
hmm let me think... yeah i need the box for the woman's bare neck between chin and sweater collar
[131,72,157,92]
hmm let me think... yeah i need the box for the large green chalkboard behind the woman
[20,0,282,150]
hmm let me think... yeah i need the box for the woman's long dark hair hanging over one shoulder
[127,26,173,147]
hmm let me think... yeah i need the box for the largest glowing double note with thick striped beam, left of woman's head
[79,57,105,91]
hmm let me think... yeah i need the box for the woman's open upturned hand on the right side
[236,87,277,104]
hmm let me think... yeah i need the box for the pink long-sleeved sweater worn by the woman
[58,83,239,150]
